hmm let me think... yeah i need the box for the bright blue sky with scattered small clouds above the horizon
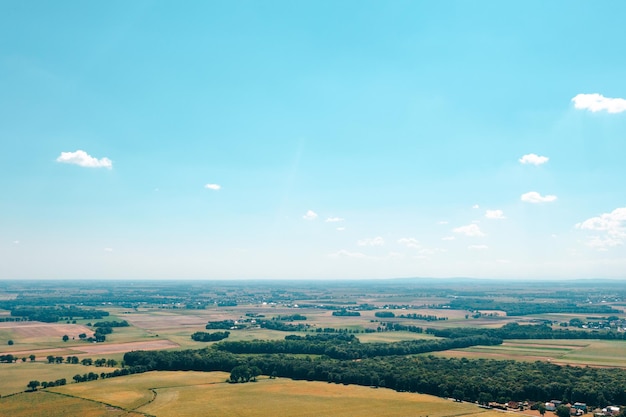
[0,0,626,279]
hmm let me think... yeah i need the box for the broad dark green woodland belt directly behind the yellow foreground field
[124,345,626,406]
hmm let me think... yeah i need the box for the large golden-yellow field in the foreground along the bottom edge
[42,372,508,417]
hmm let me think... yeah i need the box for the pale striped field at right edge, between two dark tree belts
[437,339,626,368]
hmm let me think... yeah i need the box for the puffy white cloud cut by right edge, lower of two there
[576,207,626,249]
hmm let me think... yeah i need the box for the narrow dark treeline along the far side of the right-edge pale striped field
[426,323,626,340]
